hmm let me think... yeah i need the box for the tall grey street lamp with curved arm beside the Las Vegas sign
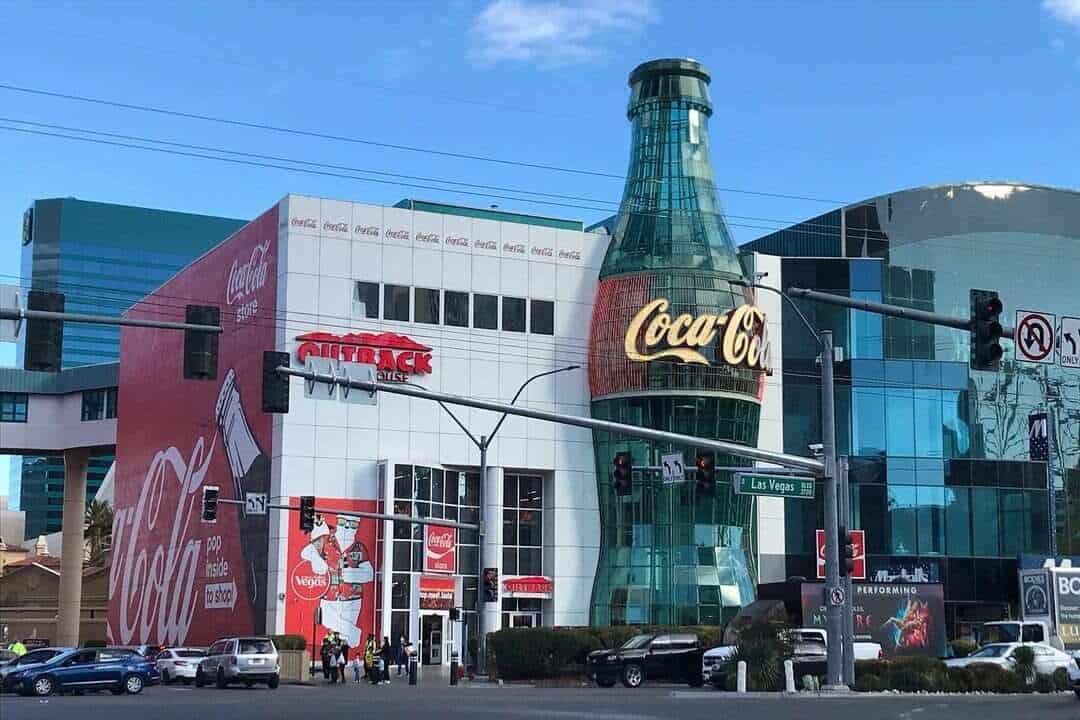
[731,280,854,689]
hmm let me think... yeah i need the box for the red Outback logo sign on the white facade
[296,332,431,382]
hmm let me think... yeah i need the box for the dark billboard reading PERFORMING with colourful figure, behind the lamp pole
[801,583,946,657]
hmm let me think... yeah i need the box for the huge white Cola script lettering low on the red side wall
[109,437,217,646]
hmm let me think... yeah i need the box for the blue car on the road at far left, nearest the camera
[8,648,159,696]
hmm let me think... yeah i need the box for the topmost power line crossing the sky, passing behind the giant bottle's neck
[0,83,847,205]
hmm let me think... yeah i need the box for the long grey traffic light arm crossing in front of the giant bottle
[278,366,825,476]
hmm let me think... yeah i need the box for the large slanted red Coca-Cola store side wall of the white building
[108,206,279,644]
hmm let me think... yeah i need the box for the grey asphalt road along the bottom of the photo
[0,683,1080,720]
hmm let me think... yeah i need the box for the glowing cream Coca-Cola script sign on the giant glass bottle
[624,298,769,370]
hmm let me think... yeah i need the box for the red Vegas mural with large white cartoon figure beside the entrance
[285,498,382,658]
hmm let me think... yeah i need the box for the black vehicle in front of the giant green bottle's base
[586,634,703,688]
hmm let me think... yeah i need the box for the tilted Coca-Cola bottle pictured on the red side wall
[215,368,270,633]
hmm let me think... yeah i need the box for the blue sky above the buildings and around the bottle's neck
[0,0,1080,498]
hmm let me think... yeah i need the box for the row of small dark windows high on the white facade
[353,282,555,335]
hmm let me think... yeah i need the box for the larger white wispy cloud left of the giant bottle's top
[469,0,653,68]
